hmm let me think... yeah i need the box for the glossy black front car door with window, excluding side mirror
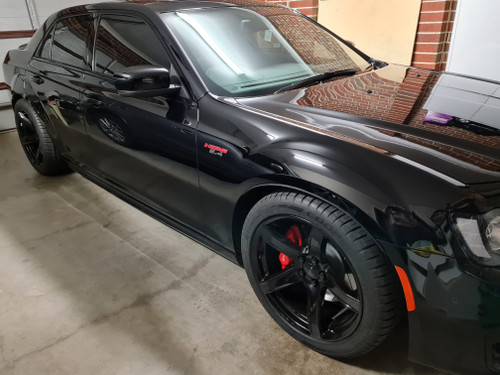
[82,13,202,229]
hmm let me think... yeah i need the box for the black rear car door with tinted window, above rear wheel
[26,14,94,159]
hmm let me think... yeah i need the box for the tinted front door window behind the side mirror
[95,15,170,75]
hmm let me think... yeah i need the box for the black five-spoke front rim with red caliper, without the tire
[252,217,363,341]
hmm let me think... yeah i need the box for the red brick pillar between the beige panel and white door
[412,0,457,70]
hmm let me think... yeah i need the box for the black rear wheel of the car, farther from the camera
[14,99,71,176]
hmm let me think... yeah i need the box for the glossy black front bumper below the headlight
[406,248,500,375]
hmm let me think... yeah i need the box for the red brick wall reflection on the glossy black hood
[297,69,500,171]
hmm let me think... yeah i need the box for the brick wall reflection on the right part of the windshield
[267,14,356,72]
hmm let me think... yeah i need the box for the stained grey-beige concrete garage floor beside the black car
[0,132,442,375]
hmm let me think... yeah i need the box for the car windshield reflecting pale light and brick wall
[163,7,369,97]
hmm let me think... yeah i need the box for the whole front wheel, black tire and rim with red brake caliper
[242,192,402,358]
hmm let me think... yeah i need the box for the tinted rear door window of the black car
[51,16,93,68]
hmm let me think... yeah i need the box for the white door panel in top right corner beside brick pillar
[447,0,500,81]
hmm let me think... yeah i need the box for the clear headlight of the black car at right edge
[455,209,500,266]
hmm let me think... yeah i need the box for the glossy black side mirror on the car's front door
[113,65,181,97]
